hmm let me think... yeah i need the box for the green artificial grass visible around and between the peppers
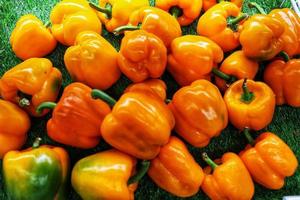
[0,0,300,200]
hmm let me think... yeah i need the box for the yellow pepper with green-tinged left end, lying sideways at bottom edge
[71,150,137,200]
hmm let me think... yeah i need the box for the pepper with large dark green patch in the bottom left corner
[3,138,69,200]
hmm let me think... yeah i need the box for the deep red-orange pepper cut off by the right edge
[264,59,300,107]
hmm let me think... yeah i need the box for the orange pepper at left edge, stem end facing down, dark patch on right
[0,58,62,116]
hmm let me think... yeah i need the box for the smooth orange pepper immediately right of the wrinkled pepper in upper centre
[168,35,223,86]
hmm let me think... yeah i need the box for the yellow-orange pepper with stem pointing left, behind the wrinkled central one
[114,7,182,47]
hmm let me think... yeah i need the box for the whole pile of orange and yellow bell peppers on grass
[0,0,300,200]
